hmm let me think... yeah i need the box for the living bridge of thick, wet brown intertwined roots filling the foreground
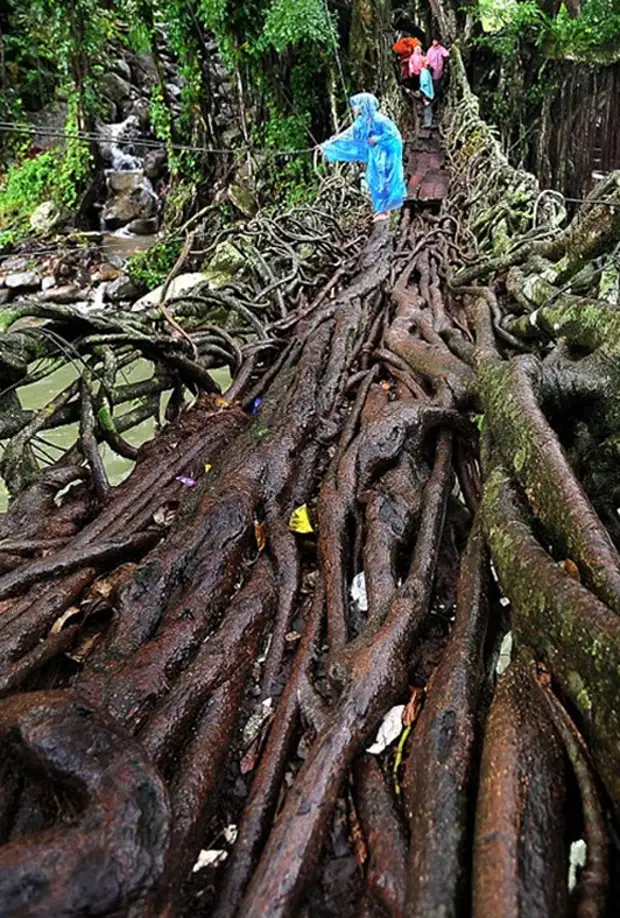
[0,77,620,918]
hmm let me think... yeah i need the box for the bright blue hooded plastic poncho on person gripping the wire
[321,92,406,213]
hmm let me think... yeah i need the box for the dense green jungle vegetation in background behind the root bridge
[0,0,620,252]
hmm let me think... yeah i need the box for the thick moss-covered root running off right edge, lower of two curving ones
[481,465,620,814]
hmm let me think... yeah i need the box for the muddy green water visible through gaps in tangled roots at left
[0,360,231,513]
